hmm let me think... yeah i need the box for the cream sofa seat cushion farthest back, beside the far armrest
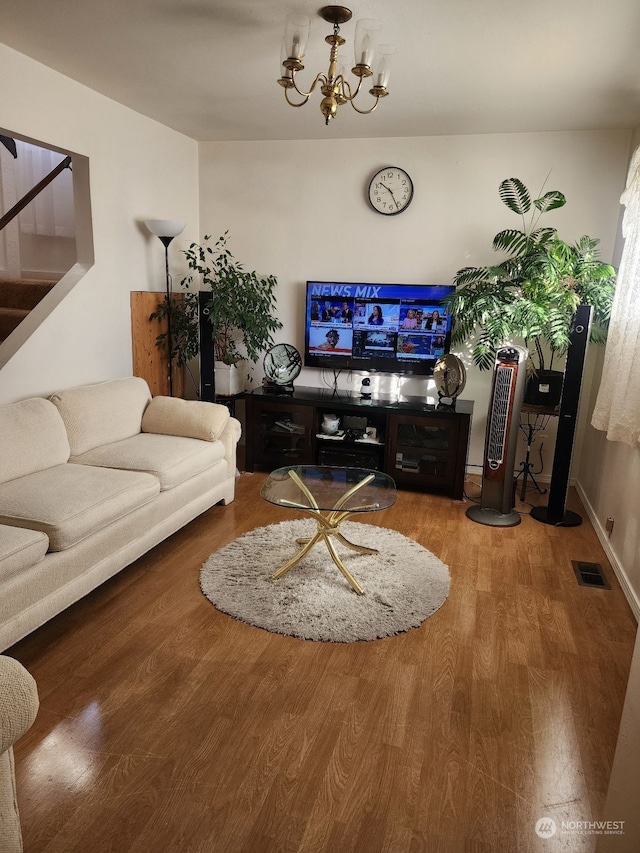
[71,433,224,491]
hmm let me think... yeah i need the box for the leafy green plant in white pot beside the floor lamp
[152,231,282,394]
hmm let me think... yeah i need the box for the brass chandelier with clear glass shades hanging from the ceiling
[278,6,395,124]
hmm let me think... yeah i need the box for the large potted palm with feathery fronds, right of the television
[448,178,615,403]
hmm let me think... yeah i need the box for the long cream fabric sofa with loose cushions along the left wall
[0,377,240,650]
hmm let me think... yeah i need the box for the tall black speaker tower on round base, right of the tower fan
[531,305,593,527]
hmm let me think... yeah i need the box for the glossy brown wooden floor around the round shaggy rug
[9,474,636,853]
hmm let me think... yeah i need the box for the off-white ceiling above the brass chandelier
[0,0,640,140]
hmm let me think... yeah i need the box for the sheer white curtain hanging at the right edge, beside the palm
[591,147,640,449]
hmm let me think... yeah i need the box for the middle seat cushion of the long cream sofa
[0,462,160,551]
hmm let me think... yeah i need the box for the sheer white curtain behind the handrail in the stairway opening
[16,139,75,237]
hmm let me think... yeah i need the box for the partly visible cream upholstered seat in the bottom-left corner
[0,655,38,853]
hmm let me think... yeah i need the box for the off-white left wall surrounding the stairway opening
[0,45,198,402]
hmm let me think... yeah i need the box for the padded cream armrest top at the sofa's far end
[142,397,230,441]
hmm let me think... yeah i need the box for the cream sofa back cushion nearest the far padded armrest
[49,376,151,457]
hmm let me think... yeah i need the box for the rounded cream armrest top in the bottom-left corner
[0,655,39,755]
